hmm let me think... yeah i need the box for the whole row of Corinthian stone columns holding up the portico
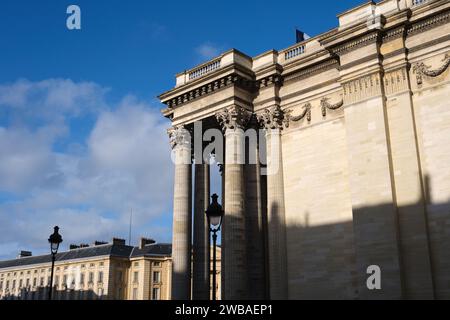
[169,106,288,300]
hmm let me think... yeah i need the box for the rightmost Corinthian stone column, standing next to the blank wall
[259,106,288,300]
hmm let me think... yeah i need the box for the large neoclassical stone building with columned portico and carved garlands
[160,0,450,299]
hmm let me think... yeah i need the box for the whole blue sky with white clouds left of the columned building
[0,0,361,259]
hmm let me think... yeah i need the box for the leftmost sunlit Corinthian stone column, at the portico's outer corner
[168,127,192,300]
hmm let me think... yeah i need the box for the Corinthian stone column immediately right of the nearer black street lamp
[216,106,249,300]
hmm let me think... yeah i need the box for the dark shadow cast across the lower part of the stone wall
[185,177,450,300]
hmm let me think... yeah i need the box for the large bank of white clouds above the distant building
[0,80,172,258]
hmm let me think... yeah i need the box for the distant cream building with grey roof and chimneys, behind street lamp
[0,238,220,300]
